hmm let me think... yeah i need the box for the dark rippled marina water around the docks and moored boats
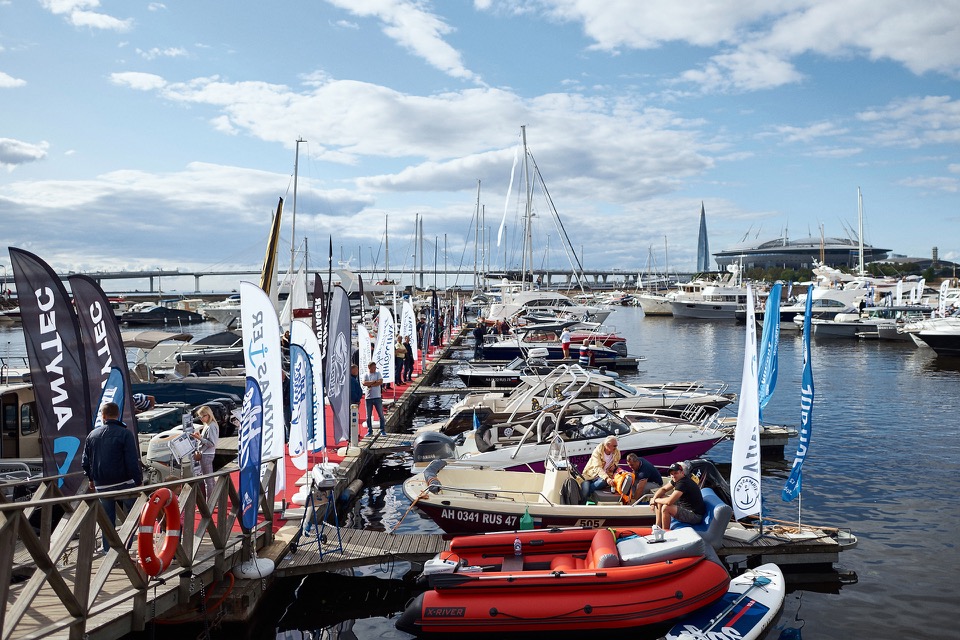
[0,307,960,640]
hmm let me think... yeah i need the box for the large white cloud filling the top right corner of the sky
[516,0,960,92]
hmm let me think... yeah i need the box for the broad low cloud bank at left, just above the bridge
[0,162,372,270]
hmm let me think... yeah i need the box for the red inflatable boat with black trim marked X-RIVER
[396,528,730,635]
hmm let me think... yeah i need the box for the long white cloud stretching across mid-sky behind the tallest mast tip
[113,73,721,206]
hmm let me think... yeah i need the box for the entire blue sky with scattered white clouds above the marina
[0,0,960,290]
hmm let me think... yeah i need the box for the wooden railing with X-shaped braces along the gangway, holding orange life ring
[0,460,276,640]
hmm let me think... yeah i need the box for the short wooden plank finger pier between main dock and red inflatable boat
[276,525,447,578]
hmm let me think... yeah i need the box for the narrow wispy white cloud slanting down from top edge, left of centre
[327,0,477,80]
